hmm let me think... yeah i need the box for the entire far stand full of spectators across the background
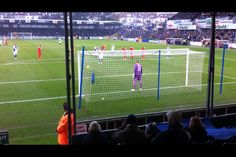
[0,12,236,41]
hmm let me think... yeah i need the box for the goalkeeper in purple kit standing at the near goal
[131,61,143,91]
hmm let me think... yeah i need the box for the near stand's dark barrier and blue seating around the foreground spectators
[72,105,236,145]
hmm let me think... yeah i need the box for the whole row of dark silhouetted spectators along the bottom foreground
[61,111,213,145]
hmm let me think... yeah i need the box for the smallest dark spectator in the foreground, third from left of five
[145,122,161,142]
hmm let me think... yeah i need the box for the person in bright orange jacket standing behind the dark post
[56,103,74,145]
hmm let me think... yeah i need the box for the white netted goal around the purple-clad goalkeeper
[78,49,205,102]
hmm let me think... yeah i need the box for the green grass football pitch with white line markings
[0,40,236,144]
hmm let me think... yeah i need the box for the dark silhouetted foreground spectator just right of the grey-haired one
[112,114,148,145]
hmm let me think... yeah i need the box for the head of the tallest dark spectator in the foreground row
[166,111,182,126]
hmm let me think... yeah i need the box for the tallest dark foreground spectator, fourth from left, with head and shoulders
[152,111,191,145]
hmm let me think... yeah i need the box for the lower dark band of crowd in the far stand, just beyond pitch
[0,23,236,41]
